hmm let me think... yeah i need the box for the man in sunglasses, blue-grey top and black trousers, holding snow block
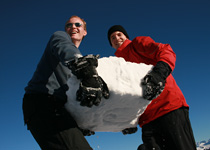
[23,16,109,150]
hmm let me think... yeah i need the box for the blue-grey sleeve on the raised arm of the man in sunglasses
[49,31,82,65]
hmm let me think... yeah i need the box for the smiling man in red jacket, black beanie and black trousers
[108,25,196,150]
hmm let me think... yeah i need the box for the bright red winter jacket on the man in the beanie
[115,36,189,127]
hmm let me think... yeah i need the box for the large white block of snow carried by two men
[66,57,152,132]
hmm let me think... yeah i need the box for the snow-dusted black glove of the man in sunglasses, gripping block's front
[68,55,109,107]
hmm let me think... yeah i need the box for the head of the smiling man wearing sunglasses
[65,17,87,43]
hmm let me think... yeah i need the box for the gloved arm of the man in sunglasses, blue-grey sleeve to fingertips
[49,31,109,107]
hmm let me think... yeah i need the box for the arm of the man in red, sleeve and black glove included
[134,37,176,100]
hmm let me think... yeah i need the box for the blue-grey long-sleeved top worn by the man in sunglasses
[25,31,81,99]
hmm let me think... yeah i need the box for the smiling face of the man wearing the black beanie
[110,31,127,50]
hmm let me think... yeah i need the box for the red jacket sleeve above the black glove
[132,36,176,70]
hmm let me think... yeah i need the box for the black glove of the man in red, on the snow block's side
[142,61,172,100]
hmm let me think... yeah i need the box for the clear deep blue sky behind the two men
[0,0,210,150]
